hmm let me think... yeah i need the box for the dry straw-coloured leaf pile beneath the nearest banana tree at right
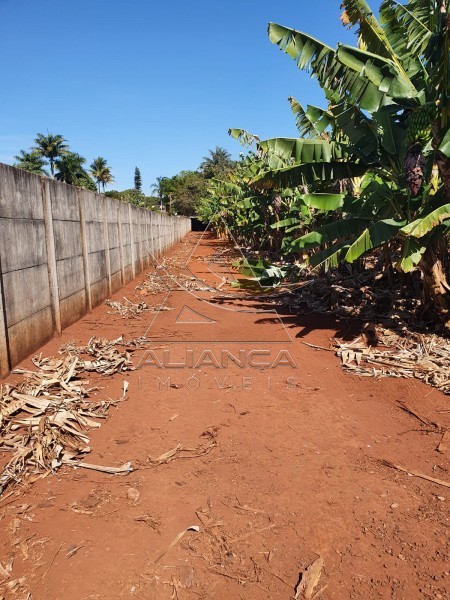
[336,329,450,394]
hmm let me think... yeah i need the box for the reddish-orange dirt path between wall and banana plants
[0,233,450,600]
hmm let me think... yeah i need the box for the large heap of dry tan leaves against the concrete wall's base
[0,338,133,494]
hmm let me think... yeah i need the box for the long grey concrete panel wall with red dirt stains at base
[0,163,191,376]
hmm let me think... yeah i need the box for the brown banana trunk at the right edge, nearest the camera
[420,242,450,327]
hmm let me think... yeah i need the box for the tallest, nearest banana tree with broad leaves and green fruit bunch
[248,0,450,321]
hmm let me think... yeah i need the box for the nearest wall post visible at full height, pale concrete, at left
[41,177,62,335]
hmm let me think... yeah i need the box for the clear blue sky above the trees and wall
[0,0,379,193]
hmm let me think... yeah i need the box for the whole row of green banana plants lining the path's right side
[199,0,450,326]
